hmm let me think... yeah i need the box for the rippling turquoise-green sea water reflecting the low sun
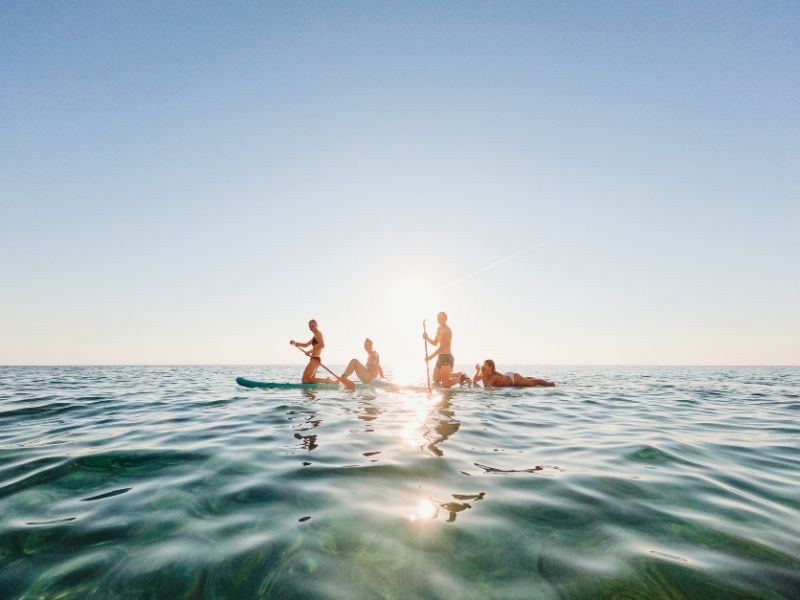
[0,367,800,599]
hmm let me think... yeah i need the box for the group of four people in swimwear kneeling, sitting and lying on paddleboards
[289,312,555,388]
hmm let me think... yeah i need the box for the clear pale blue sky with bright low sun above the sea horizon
[0,0,800,377]
